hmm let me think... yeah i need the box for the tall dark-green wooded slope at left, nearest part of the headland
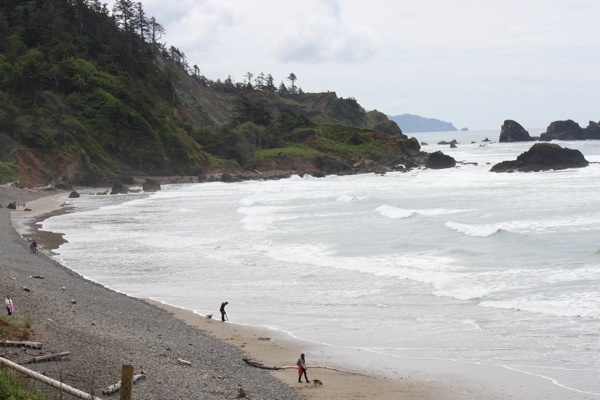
[0,0,205,176]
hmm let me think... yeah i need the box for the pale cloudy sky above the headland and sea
[108,0,600,130]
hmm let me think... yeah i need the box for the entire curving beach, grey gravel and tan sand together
[0,188,595,400]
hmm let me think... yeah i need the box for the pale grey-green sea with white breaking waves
[43,131,600,395]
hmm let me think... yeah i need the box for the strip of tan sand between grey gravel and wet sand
[141,298,450,400]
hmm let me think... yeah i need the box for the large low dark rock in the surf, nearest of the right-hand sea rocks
[491,143,589,172]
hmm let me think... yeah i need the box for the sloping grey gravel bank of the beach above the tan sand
[0,187,305,400]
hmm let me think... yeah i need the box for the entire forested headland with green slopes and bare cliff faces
[0,0,419,186]
